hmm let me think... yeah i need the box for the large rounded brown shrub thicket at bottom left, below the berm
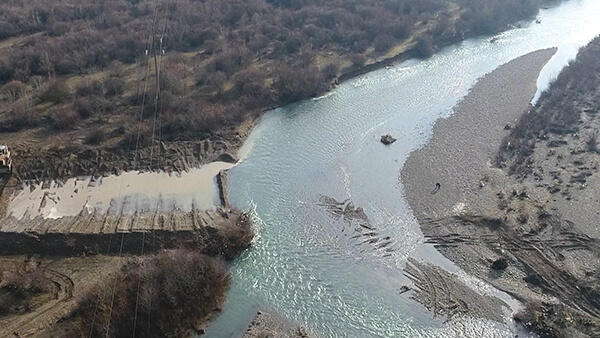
[55,250,230,338]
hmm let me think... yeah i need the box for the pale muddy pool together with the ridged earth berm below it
[0,162,252,259]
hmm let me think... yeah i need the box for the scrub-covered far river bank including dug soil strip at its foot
[0,0,564,185]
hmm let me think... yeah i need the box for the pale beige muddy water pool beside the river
[7,162,232,219]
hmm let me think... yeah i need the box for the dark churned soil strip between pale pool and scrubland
[7,113,258,181]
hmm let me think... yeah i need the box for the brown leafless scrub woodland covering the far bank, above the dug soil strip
[0,0,556,177]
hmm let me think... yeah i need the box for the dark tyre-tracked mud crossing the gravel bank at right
[426,216,600,320]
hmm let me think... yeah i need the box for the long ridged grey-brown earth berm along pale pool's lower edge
[0,207,247,256]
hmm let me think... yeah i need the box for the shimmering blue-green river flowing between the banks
[206,0,600,337]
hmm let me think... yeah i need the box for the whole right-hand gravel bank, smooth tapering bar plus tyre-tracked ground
[401,45,596,334]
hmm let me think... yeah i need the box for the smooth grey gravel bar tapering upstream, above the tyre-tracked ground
[401,48,557,222]
